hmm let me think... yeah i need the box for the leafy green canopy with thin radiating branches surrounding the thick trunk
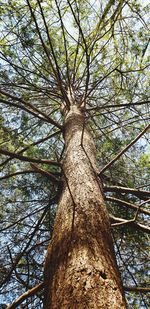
[0,0,150,308]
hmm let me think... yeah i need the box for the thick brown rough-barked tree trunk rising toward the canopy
[44,105,127,309]
